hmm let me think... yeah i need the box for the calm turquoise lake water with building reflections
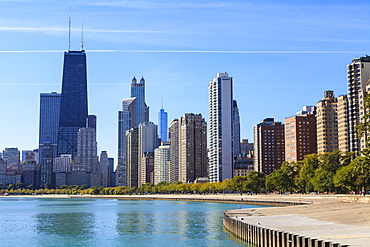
[0,198,259,247]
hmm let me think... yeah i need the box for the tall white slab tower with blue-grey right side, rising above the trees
[208,73,233,182]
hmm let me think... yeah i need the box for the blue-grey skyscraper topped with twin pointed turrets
[131,77,149,127]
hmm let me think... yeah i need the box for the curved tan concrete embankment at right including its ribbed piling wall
[223,196,370,247]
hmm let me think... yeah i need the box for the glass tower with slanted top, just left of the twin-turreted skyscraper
[116,97,136,186]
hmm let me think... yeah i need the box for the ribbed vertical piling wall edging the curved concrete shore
[223,211,348,247]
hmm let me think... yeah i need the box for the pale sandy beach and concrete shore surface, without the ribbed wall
[1,194,370,246]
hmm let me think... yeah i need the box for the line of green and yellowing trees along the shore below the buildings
[0,150,370,195]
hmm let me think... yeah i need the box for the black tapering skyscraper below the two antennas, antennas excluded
[57,50,88,158]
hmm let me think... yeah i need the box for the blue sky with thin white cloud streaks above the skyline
[0,0,370,164]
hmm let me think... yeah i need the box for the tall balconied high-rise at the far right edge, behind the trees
[347,56,370,152]
